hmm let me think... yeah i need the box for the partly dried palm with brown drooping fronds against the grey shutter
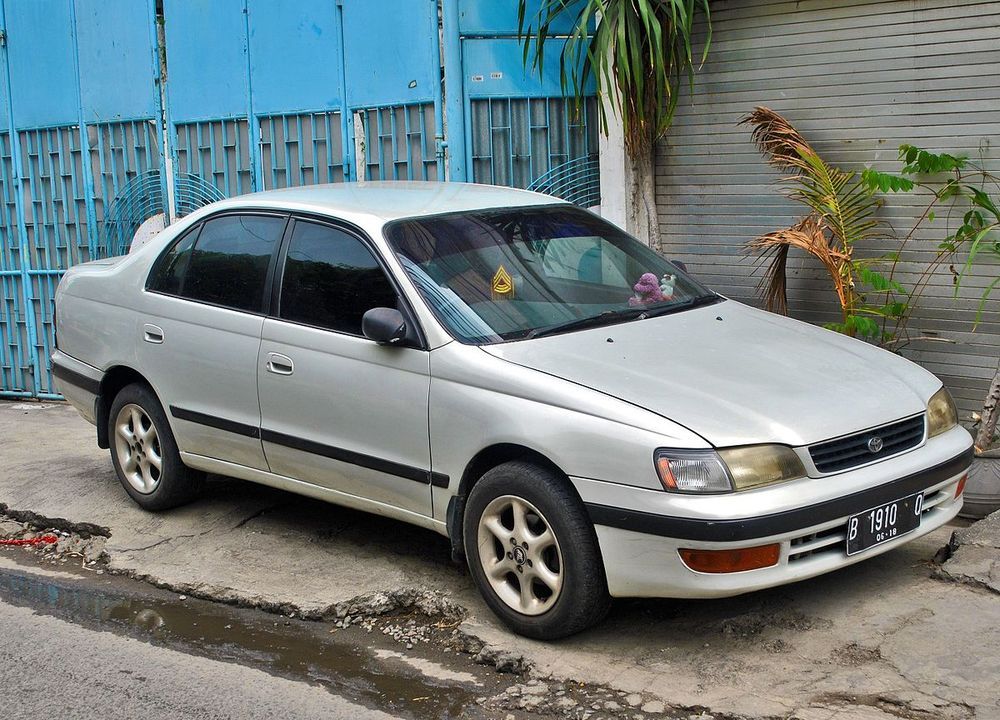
[740,107,909,341]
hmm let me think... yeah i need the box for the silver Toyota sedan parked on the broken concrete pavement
[52,183,972,638]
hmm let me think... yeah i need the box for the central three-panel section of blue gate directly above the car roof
[164,0,443,196]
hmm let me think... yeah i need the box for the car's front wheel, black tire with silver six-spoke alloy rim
[462,461,611,640]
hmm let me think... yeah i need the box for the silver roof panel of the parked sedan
[211,181,565,222]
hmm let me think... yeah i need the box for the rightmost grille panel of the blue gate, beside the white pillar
[471,98,598,195]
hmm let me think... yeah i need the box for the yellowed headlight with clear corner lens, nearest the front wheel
[656,445,806,493]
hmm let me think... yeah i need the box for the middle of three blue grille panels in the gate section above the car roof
[260,112,344,190]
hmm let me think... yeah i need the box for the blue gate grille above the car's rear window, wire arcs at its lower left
[176,118,254,197]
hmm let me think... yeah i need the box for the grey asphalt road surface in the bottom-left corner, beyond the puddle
[0,592,391,720]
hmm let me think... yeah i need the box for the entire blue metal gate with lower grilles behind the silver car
[0,0,597,398]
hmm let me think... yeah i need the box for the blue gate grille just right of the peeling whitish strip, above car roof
[354,103,438,180]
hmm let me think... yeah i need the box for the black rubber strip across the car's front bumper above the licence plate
[586,448,972,542]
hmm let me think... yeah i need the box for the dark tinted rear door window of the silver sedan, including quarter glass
[148,215,285,312]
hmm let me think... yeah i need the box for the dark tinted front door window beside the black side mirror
[280,221,397,335]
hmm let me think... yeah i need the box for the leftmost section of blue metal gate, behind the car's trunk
[0,0,160,398]
